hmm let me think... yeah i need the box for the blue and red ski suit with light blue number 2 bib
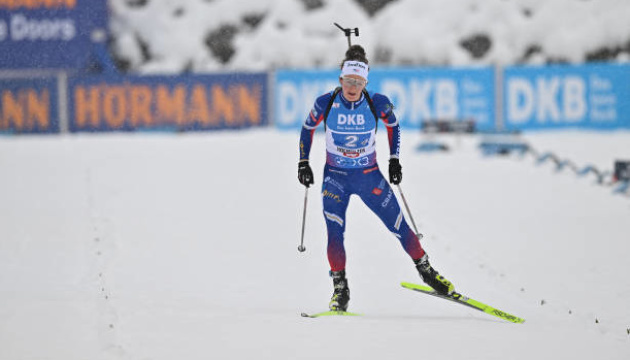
[300,88,424,271]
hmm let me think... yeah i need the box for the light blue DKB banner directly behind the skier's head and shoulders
[274,68,495,130]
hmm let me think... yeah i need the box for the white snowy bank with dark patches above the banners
[109,0,630,73]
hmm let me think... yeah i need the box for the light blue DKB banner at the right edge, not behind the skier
[503,64,630,130]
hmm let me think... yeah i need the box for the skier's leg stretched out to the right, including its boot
[358,170,455,294]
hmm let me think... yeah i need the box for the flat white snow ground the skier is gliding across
[0,129,630,360]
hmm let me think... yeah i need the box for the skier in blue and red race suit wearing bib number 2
[298,45,455,311]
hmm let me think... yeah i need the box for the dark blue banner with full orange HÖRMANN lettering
[68,73,269,132]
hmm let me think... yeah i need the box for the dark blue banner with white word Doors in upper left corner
[0,0,108,69]
